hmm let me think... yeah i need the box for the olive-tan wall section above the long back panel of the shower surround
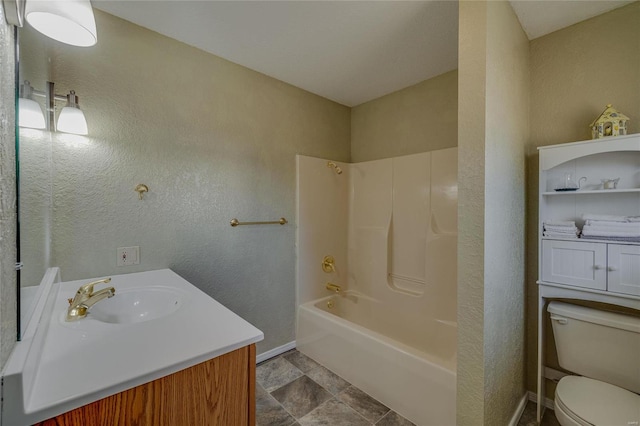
[351,70,458,162]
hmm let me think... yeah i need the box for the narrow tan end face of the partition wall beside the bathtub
[456,2,487,426]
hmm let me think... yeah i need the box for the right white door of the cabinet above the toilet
[607,244,640,296]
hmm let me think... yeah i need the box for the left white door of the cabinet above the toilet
[542,240,607,290]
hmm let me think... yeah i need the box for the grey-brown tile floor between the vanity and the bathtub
[256,349,413,426]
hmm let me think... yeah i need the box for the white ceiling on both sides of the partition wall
[93,0,630,106]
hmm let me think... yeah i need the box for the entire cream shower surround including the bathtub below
[296,148,457,425]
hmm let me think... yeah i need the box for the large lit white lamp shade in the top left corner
[2,0,98,47]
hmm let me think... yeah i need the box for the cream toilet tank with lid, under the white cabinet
[547,302,640,393]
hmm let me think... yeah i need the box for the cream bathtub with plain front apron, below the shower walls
[296,292,456,426]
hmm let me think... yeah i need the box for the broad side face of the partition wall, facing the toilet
[484,1,529,425]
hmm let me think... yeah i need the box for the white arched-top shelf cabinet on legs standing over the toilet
[537,134,640,422]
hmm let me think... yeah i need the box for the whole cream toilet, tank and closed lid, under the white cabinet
[547,302,640,426]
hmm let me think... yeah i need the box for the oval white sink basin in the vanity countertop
[88,287,186,324]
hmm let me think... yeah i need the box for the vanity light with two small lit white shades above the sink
[18,81,89,135]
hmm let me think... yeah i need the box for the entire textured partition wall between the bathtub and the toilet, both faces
[457,1,529,425]
